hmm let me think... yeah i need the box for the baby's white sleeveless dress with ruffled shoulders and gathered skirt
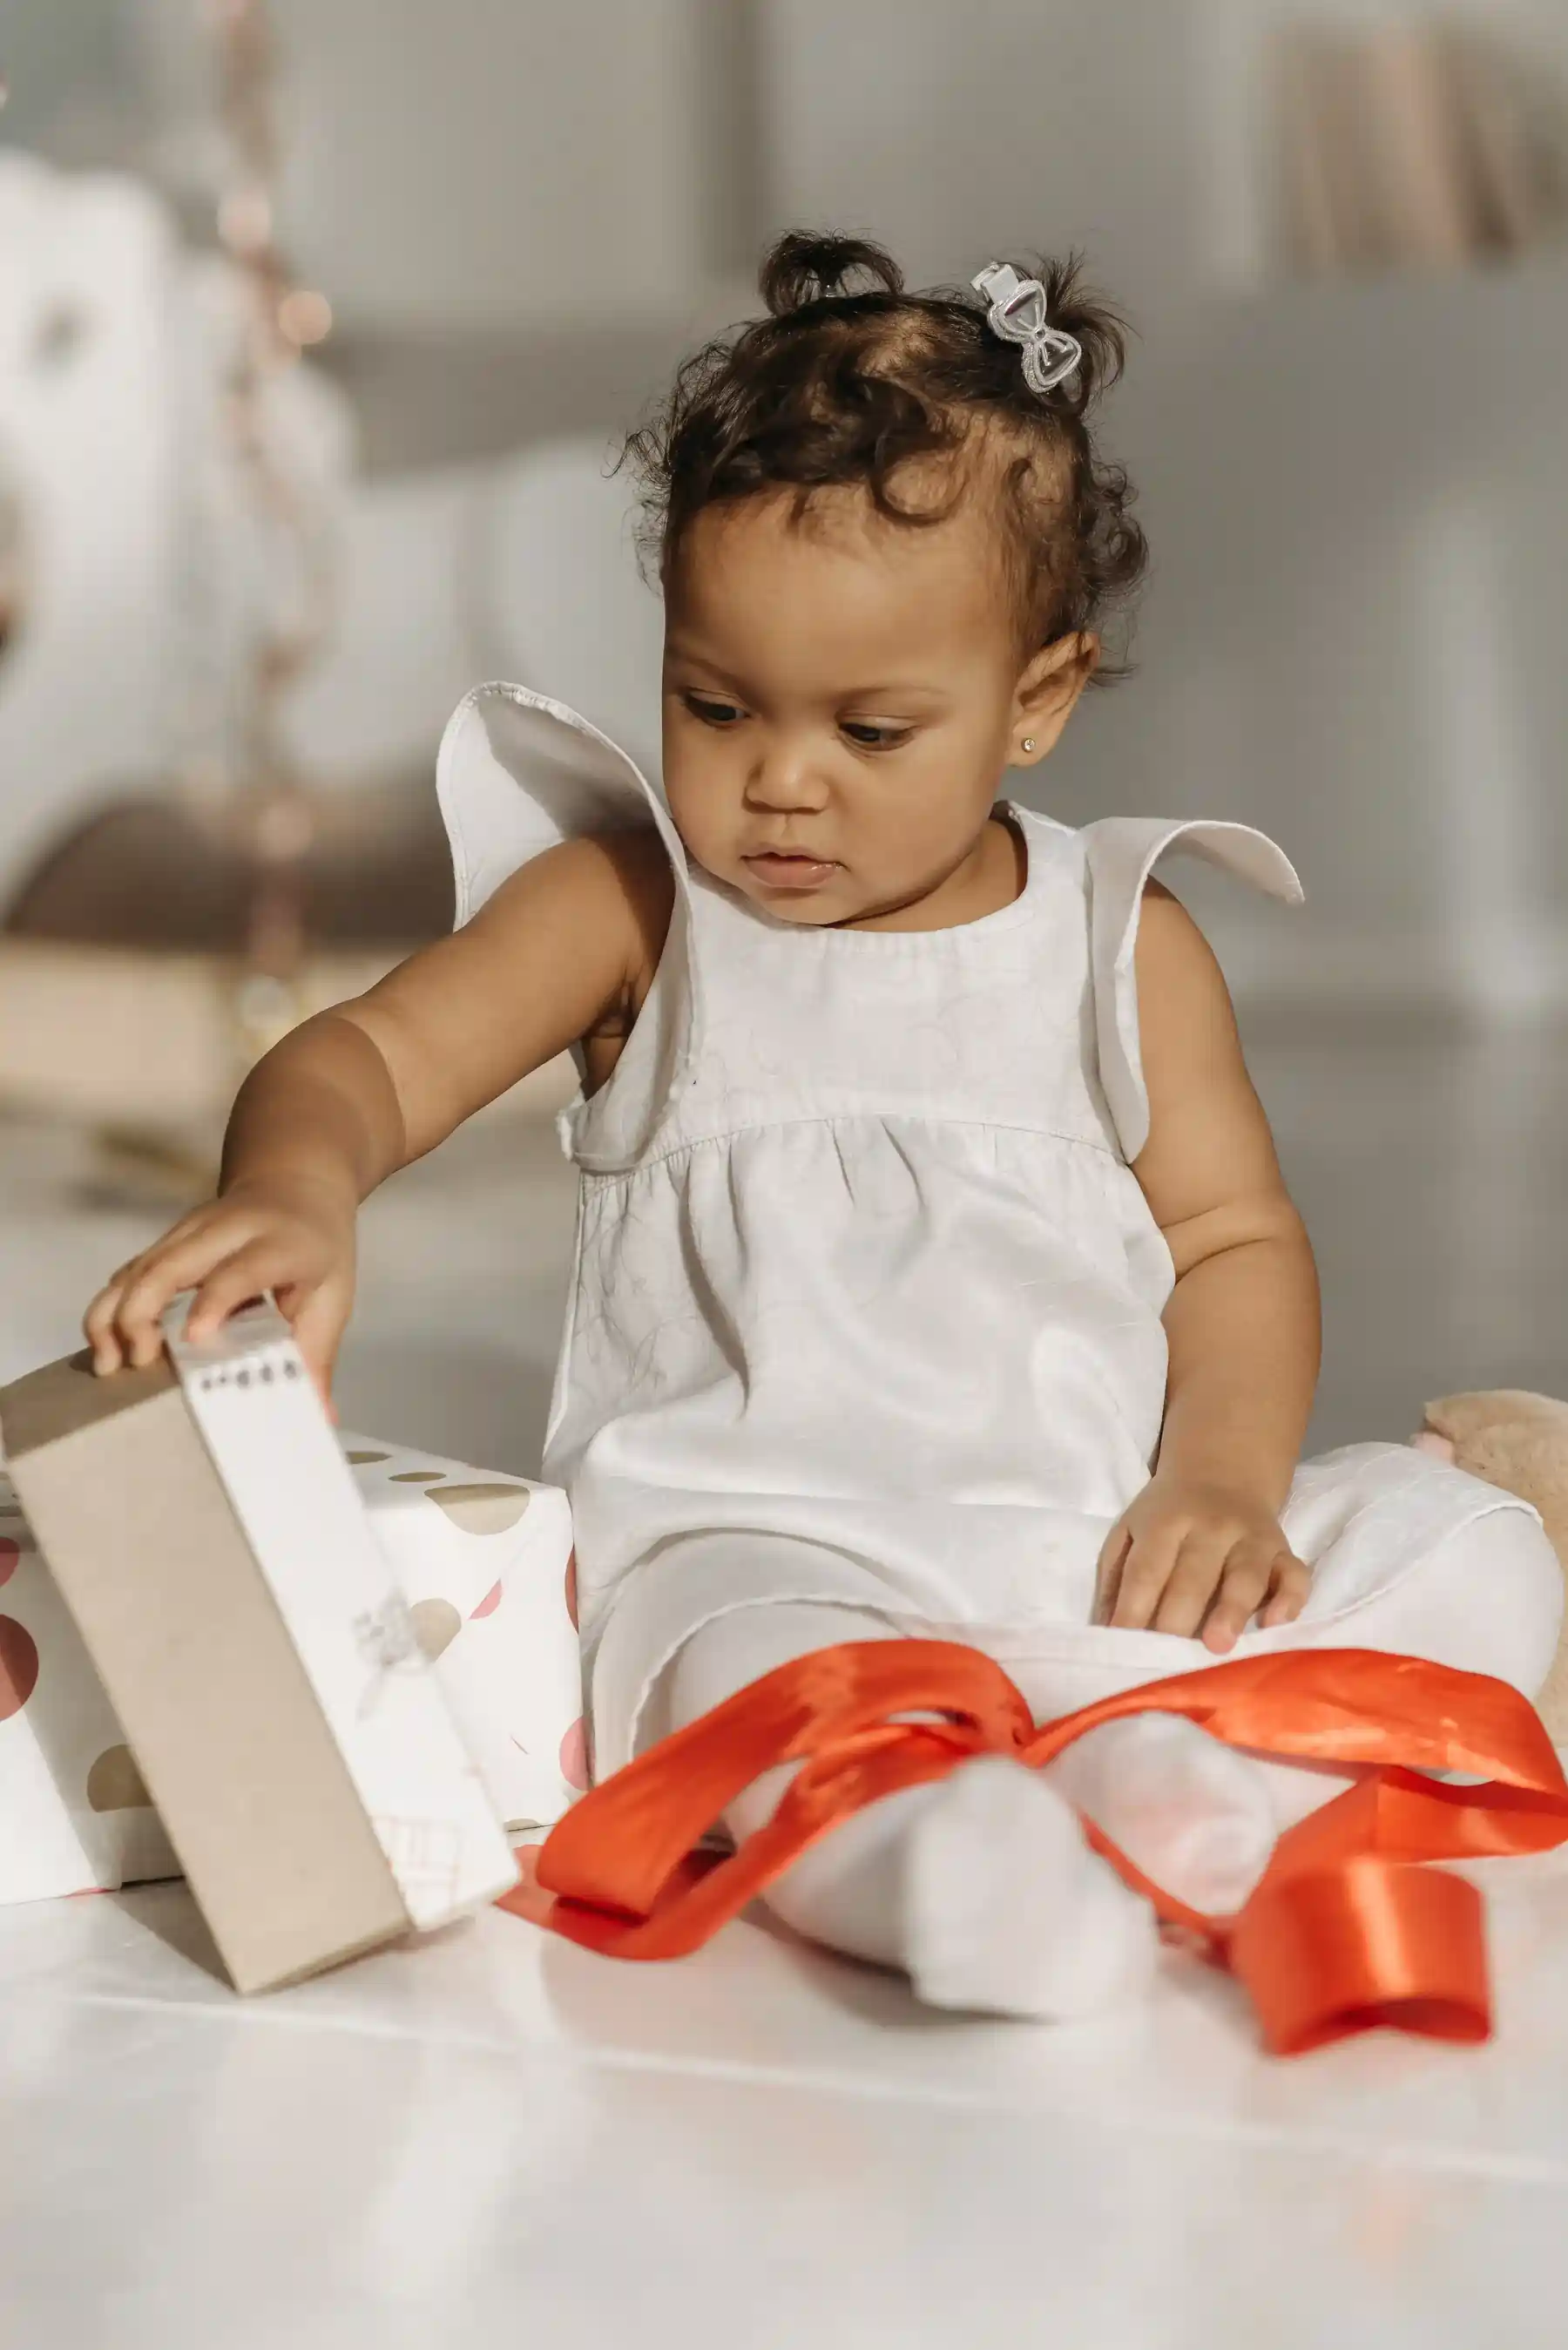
[440,687,1549,1774]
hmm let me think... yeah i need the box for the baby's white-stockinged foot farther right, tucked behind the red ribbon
[1046,1713,1276,1918]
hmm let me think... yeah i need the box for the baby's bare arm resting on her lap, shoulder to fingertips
[1103,884,1319,1649]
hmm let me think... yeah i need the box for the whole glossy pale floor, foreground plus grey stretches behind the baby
[0,1032,1568,2350]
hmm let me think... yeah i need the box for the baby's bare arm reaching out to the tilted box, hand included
[87,832,672,1389]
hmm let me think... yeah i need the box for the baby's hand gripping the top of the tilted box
[82,1175,355,1396]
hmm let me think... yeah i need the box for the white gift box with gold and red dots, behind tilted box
[0,1334,588,1954]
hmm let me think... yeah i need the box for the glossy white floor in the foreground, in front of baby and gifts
[0,1859,1568,2350]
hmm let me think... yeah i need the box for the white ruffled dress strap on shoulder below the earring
[1081,816,1305,1166]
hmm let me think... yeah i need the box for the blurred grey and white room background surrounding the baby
[0,0,1568,1469]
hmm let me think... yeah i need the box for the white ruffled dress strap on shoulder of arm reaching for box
[435,684,698,1170]
